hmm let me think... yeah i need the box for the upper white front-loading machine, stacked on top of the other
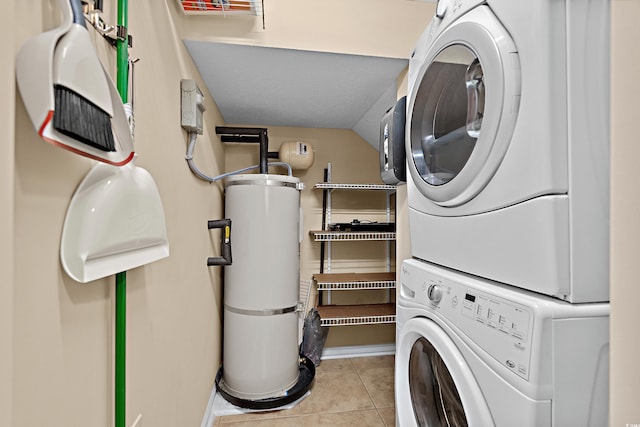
[406,0,609,303]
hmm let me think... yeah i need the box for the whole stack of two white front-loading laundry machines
[395,0,609,427]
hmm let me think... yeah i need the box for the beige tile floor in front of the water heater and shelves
[214,356,395,427]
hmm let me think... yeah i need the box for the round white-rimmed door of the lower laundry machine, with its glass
[395,318,494,427]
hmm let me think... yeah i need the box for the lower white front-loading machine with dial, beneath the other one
[395,260,609,427]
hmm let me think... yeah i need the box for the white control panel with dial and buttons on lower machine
[401,262,534,380]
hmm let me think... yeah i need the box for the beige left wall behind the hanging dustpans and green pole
[11,0,224,427]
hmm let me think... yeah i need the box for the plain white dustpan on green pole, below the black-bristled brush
[60,162,169,283]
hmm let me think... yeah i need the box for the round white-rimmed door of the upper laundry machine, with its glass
[406,6,520,207]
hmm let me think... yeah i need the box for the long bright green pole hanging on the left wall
[114,0,129,427]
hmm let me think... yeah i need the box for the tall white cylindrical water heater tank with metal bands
[222,174,301,406]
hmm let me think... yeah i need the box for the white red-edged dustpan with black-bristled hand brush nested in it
[16,0,135,166]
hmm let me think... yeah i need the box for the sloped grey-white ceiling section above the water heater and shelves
[184,40,408,148]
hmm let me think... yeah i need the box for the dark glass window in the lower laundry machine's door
[409,338,468,427]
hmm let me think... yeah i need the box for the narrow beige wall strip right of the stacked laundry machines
[610,0,640,427]
